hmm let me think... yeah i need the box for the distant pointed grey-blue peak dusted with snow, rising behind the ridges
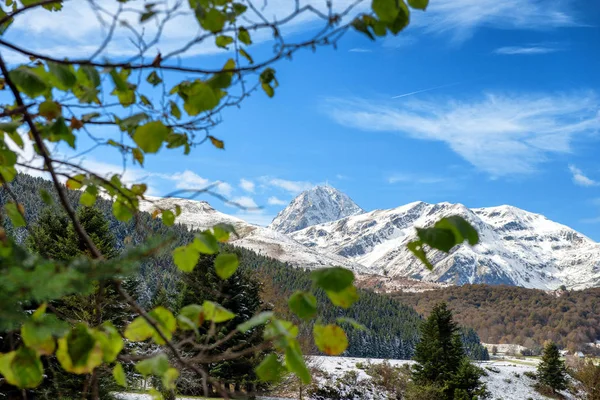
[269,185,364,233]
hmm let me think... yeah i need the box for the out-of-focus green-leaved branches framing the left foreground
[0,0,477,399]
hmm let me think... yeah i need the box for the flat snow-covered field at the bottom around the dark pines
[118,356,581,400]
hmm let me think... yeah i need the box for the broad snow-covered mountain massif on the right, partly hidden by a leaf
[291,202,600,289]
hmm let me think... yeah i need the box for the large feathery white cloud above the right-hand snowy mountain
[324,92,600,177]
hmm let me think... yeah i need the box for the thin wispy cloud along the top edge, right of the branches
[413,0,579,41]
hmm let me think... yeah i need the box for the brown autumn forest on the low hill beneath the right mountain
[392,285,600,351]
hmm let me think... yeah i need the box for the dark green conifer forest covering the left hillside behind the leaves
[0,174,489,359]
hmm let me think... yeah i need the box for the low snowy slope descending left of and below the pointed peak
[140,196,360,269]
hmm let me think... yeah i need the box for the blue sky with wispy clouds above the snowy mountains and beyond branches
[4,0,600,240]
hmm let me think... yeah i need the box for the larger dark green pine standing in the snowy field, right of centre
[412,303,486,400]
